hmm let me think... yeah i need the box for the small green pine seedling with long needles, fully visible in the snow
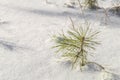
[53,20,100,68]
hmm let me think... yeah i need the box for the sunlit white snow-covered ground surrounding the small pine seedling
[0,0,120,80]
